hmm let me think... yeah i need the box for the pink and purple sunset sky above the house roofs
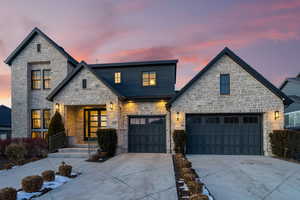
[0,0,300,106]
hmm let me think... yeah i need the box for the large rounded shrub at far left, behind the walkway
[5,143,27,164]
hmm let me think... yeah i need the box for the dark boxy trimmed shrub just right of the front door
[97,129,118,157]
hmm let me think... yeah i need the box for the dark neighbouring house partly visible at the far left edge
[0,105,11,139]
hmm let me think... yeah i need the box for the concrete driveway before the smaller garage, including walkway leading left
[0,154,177,200]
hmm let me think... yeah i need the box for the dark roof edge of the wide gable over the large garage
[167,47,293,107]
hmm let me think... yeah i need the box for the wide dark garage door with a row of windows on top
[186,114,262,155]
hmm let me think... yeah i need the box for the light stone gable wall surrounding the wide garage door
[171,56,284,155]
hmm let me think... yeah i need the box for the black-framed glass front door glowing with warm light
[84,109,107,140]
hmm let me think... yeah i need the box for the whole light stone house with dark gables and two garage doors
[5,28,292,155]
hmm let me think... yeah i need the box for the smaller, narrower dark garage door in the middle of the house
[128,116,166,153]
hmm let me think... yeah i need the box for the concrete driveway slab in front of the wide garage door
[188,155,300,200]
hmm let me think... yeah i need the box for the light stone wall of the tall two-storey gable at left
[11,35,68,137]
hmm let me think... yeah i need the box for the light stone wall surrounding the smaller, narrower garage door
[120,101,170,153]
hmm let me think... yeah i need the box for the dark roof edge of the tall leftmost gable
[4,27,78,66]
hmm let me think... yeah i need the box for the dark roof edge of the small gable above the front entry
[47,61,124,101]
